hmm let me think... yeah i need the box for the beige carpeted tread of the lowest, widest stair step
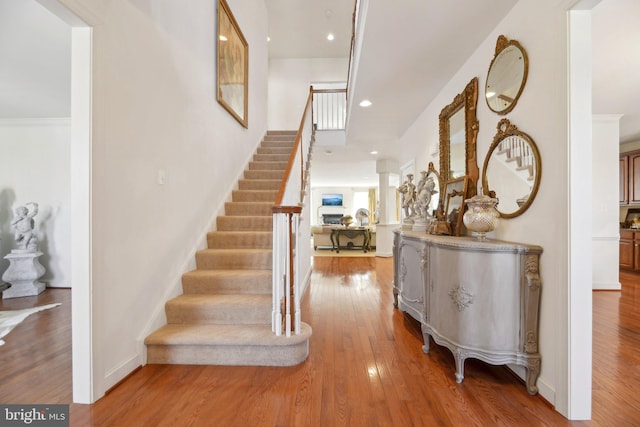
[145,322,311,346]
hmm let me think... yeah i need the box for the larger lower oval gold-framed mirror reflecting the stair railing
[482,119,542,218]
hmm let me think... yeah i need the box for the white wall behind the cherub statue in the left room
[0,119,72,287]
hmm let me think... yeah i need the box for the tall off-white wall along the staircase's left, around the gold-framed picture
[62,0,268,398]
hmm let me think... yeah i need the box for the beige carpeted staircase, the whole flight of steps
[145,131,311,366]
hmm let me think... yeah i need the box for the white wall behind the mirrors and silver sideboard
[399,0,576,414]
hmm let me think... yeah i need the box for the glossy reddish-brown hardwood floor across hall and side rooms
[0,258,640,426]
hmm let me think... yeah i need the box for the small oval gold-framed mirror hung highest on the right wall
[484,35,529,115]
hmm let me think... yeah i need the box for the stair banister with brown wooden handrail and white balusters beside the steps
[271,87,314,336]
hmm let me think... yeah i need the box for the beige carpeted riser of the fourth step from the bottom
[196,249,272,270]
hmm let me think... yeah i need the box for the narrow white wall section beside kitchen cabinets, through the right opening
[591,115,621,290]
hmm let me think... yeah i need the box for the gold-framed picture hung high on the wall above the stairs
[217,0,249,128]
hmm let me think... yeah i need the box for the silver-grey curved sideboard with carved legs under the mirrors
[393,230,542,394]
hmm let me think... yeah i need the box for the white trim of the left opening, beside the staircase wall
[31,0,94,403]
